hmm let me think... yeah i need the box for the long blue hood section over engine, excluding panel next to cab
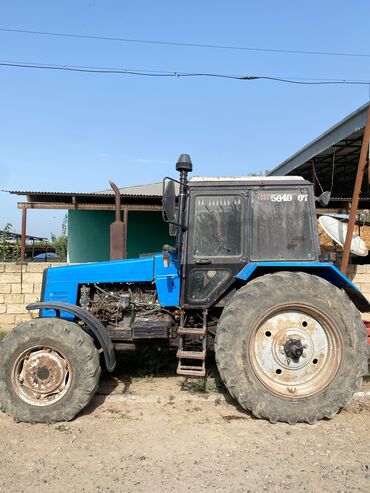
[42,257,154,319]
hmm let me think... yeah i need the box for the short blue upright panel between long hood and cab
[154,254,181,306]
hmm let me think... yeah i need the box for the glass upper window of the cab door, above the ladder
[193,195,242,257]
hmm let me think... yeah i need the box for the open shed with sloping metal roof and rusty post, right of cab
[270,103,370,273]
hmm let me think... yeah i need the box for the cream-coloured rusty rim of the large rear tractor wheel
[249,305,342,399]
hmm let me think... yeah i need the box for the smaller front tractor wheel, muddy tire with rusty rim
[0,318,101,423]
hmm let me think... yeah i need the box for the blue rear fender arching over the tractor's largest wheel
[235,262,370,312]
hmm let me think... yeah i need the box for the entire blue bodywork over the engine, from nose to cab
[42,254,180,319]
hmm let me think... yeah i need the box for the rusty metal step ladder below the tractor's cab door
[176,310,208,378]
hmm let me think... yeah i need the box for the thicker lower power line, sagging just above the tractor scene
[0,61,370,85]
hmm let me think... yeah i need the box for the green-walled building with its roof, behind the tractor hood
[10,182,174,263]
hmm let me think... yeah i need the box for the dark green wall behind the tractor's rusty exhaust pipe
[68,210,174,262]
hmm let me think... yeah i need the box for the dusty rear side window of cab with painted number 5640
[251,189,315,260]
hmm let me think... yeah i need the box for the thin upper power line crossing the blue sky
[0,28,370,58]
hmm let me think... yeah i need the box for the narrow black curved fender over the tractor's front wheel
[26,301,116,372]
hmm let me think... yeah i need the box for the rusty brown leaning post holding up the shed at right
[340,106,370,274]
